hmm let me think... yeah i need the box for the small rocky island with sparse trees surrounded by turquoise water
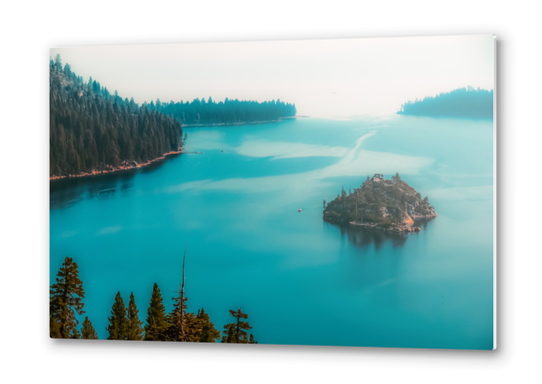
[324,173,437,233]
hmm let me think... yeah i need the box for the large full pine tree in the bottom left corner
[49,257,85,338]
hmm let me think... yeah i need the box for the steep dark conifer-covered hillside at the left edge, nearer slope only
[49,56,187,176]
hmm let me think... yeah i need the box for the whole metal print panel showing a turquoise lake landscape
[49,35,495,350]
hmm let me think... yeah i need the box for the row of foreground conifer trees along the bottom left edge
[49,251,257,344]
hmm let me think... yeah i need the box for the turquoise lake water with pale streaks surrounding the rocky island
[50,116,494,349]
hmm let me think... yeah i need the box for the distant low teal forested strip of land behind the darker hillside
[147,97,296,126]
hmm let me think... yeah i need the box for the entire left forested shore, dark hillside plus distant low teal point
[49,55,296,180]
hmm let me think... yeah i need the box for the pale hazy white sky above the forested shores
[51,35,494,117]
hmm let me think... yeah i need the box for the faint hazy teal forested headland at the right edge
[397,87,493,119]
